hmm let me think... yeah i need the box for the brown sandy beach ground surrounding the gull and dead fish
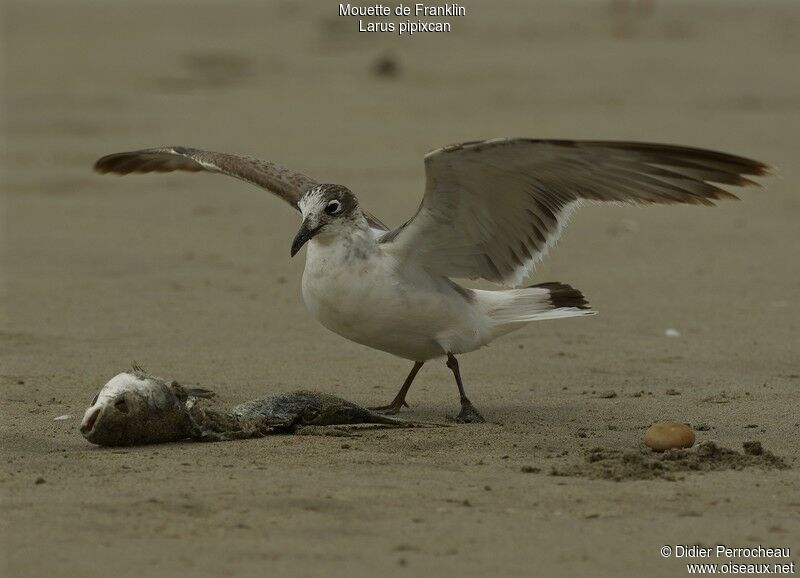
[0,0,800,578]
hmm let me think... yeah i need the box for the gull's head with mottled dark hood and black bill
[291,185,364,257]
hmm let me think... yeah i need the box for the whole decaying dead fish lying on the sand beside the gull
[80,366,421,446]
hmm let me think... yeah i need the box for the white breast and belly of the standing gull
[303,231,482,361]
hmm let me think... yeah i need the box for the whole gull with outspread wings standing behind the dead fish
[95,138,770,422]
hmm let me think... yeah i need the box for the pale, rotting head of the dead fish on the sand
[80,370,200,446]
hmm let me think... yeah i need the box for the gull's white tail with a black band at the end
[476,282,597,335]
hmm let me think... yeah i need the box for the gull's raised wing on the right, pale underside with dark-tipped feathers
[382,139,769,285]
